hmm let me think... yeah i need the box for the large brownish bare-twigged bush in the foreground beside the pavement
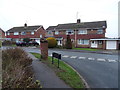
[2,48,40,88]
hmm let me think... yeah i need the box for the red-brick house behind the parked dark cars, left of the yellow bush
[6,23,45,43]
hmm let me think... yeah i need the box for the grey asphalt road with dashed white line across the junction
[1,48,118,88]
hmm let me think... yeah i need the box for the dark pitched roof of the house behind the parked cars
[7,25,42,32]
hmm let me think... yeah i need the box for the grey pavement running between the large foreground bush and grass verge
[28,53,70,88]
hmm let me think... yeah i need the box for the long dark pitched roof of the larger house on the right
[47,21,107,30]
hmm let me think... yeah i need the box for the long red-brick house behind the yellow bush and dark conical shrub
[46,19,107,47]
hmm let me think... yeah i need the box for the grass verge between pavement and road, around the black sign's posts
[32,53,85,88]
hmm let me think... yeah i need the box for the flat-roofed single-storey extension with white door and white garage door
[90,38,120,50]
